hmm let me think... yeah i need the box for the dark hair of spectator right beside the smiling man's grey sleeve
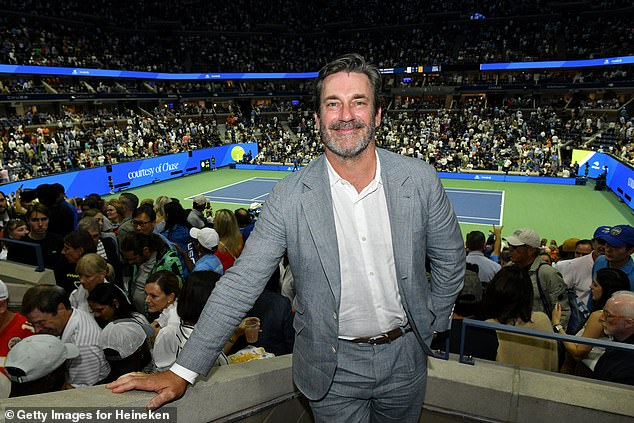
[176,270,220,325]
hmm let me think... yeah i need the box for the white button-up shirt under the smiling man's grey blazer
[327,155,406,338]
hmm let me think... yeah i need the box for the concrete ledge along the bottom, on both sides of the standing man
[0,355,634,423]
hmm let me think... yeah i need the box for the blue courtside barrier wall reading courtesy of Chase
[0,143,258,197]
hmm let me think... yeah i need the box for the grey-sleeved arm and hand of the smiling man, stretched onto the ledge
[106,182,286,409]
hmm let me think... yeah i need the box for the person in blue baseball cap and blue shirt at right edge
[592,225,634,291]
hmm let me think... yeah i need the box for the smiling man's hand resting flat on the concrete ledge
[106,370,188,410]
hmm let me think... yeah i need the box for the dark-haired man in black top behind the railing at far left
[7,203,64,269]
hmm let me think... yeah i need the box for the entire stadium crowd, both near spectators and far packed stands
[0,0,634,408]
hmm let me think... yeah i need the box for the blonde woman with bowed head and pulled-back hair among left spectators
[69,253,114,313]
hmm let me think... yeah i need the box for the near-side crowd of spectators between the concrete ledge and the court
[0,184,634,396]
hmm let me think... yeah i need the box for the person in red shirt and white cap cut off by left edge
[0,280,35,375]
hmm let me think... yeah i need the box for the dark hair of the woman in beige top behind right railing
[482,265,533,324]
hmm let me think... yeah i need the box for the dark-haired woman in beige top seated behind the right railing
[483,268,559,372]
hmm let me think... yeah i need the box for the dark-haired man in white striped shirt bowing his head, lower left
[22,285,110,388]
